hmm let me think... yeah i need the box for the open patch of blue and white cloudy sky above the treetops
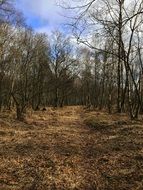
[16,0,69,33]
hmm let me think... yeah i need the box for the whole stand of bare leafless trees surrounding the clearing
[0,0,143,119]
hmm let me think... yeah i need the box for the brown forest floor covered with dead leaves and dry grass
[0,107,143,190]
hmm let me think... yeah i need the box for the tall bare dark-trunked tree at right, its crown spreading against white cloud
[61,0,143,118]
